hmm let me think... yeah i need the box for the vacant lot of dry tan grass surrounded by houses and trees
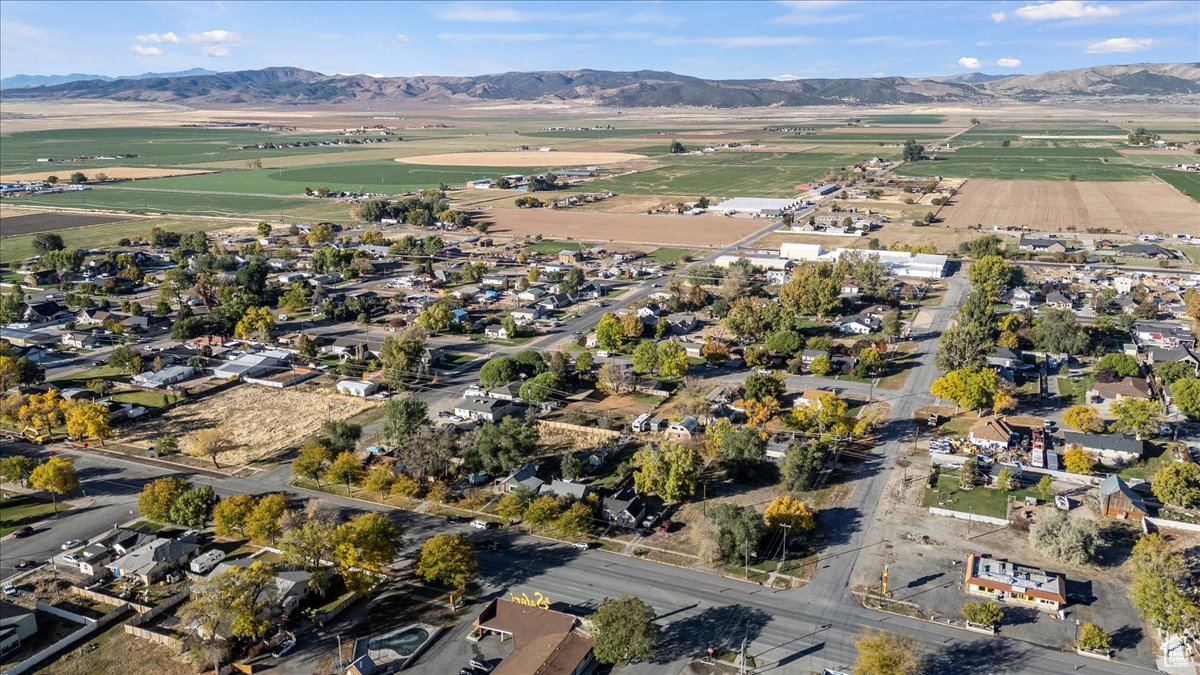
[118,384,378,465]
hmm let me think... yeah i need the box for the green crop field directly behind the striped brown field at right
[898,147,1148,180]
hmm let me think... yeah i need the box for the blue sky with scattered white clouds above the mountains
[0,0,1200,78]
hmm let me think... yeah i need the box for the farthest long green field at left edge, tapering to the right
[0,127,400,175]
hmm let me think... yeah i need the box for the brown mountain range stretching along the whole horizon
[0,64,1200,108]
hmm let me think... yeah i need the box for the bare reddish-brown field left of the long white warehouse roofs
[481,209,767,247]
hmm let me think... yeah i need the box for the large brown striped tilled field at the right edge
[940,180,1200,234]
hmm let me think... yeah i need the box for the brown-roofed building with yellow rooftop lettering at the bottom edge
[470,592,596,675]
